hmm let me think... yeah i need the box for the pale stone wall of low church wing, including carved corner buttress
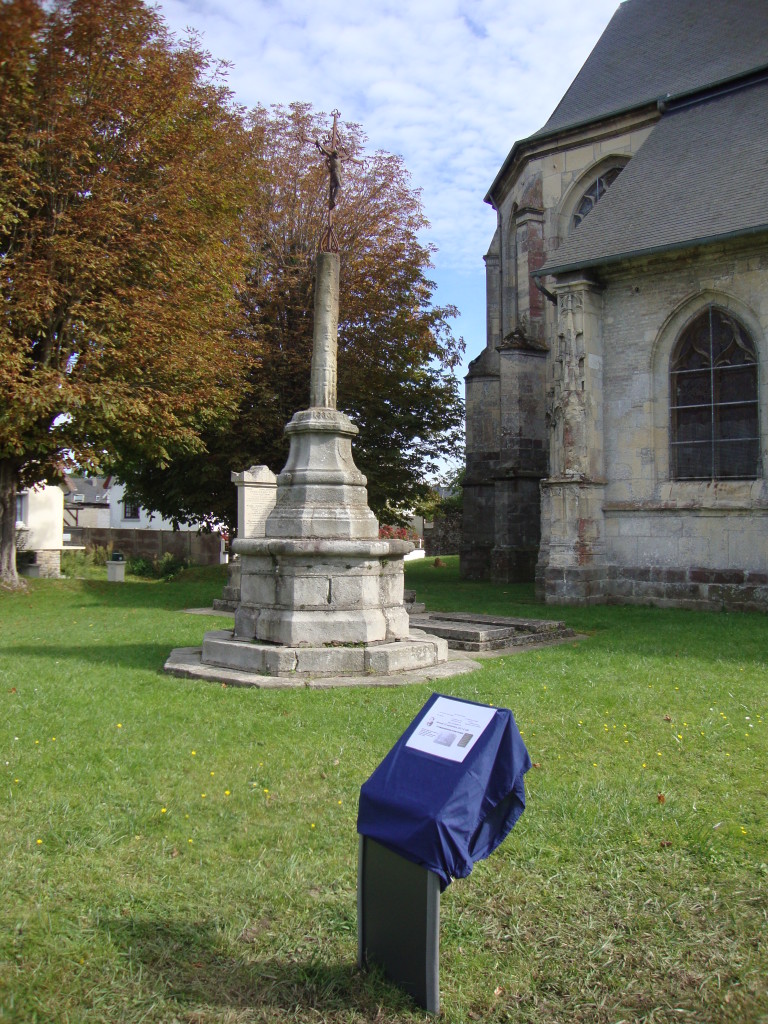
[537,238,768,608]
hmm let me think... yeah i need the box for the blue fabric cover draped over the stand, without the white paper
[357,693,530,889]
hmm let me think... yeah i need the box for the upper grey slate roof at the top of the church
[531,0,768,138]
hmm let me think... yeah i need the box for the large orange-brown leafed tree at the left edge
[0,0,259,584]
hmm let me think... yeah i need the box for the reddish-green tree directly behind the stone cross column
[121,103,464,525]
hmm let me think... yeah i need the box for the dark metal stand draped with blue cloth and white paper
[357,693,530,1013]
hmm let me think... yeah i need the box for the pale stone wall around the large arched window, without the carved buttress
[544,239,768,610]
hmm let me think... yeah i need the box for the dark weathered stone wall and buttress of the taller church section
[461,119,650,581]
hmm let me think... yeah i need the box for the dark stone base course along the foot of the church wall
[537,565,768,612]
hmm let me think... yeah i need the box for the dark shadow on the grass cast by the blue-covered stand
[103,919,415,1020]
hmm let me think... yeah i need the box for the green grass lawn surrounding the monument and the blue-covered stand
[0,558,768,1024]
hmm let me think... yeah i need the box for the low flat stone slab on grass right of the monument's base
[411,611,575,652]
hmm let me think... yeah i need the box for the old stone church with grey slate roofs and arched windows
[461,0,768,610]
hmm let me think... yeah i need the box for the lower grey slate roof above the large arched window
[541,76,768,273]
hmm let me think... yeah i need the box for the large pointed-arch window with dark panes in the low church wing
[670,306,760,480]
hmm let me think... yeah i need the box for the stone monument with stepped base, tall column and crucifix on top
[169,114,447,684]
